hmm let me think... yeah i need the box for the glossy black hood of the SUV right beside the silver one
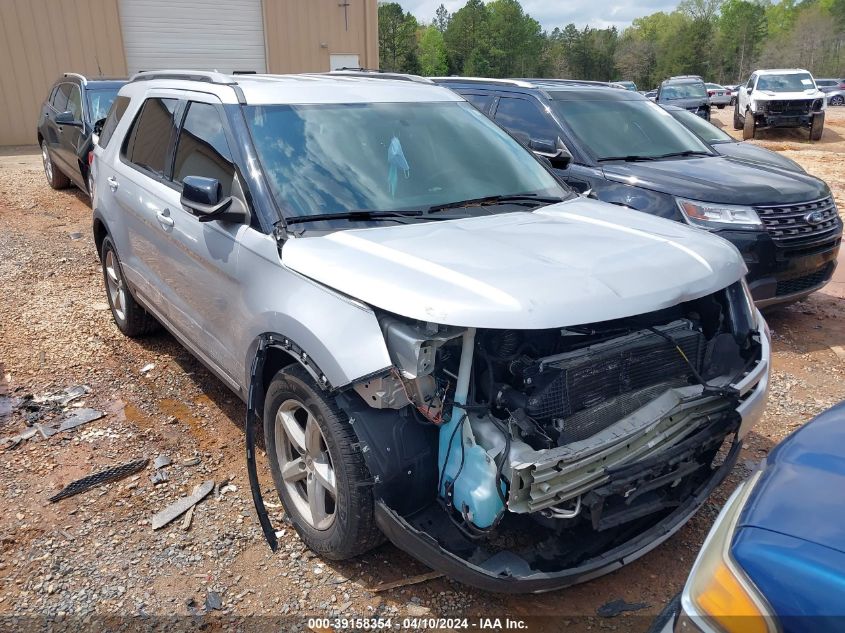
[602,156,830,206]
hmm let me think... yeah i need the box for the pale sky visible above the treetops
[395,0,678,31]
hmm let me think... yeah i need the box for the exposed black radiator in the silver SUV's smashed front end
[526,321,705,437]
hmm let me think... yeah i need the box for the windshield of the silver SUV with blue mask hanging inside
[244,102,566,217]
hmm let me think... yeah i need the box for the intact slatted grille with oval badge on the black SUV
[754,198,839,247]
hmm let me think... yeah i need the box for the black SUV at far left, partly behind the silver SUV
[38,73,126,195]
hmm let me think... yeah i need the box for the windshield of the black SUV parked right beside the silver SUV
[553,99,712,160]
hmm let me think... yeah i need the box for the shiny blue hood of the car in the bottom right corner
[739,403,845,553]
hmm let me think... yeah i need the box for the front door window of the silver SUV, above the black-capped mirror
[173,101,235,196]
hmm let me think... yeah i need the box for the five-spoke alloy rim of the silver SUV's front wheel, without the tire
[275,399,337,530]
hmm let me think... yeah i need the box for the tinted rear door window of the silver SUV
[121,97,179,176]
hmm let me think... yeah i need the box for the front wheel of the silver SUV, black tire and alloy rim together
[264,365,384,560]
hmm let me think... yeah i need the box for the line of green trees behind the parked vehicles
[378,0,845,89]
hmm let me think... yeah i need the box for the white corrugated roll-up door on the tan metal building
[120,0,266,75]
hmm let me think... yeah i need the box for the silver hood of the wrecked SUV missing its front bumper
[282,197,745,329]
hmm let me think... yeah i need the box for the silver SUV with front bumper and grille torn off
[94,71,769,592]
